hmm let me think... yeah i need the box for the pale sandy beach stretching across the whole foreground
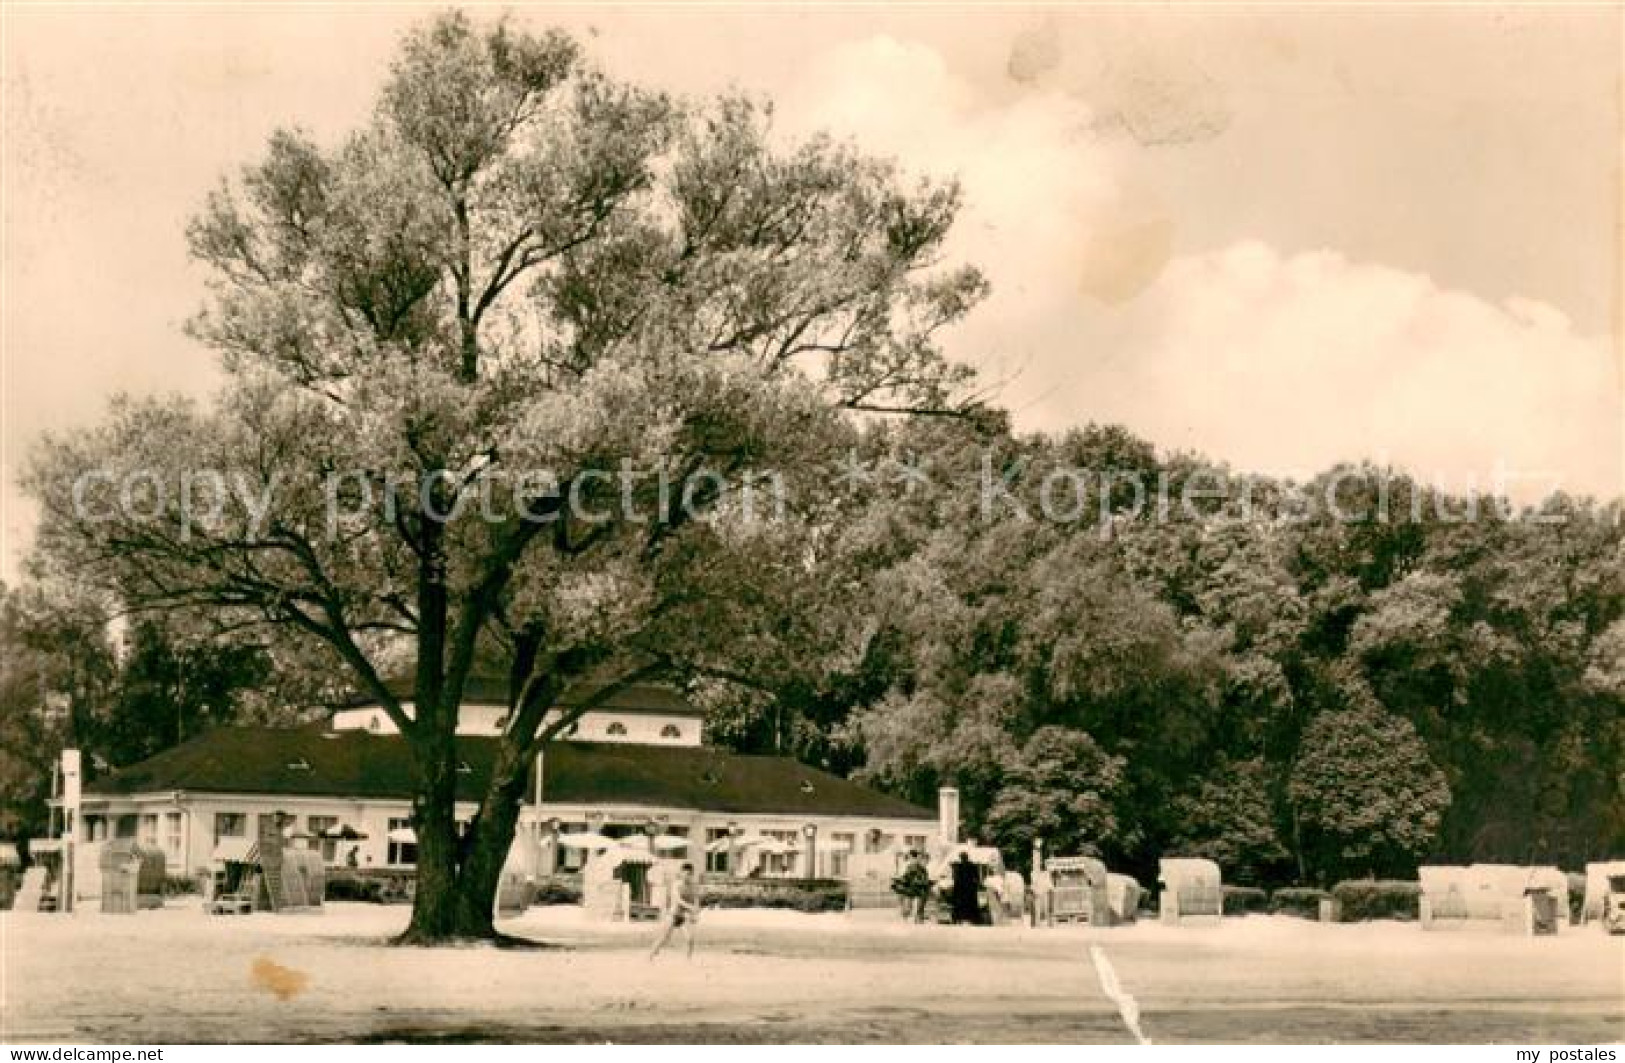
[0,902,1625,1043]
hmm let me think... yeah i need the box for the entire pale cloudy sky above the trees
[0,5,1625,582]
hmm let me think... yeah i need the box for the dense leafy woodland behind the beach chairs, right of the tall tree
[692,424,1625,884]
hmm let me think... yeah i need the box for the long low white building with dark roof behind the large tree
[76,683,939,878]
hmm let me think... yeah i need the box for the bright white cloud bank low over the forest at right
[1051,242,1622,499]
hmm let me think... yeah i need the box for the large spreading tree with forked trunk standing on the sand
[29,15,985,943]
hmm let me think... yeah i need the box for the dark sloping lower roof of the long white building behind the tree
[86,727,936,819]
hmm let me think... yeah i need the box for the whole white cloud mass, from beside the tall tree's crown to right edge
[782,37,1625,499]
